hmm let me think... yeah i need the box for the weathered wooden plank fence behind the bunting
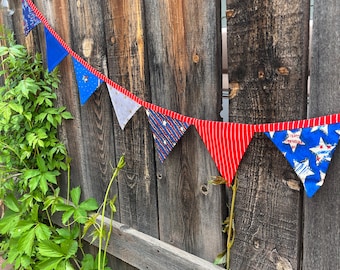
[0,0,340,270]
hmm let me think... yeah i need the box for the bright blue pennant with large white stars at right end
[265,123,340,197]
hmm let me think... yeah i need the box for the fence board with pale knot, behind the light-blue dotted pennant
[64,1,116,201]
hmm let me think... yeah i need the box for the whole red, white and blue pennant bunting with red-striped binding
[22,0,340,197]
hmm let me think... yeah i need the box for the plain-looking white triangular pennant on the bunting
[107,84,141,129]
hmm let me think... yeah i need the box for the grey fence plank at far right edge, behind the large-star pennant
[303,0,340,270]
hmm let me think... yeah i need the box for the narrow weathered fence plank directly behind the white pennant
[102,0,159,238]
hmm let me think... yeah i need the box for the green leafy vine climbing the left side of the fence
[0,29,123,270]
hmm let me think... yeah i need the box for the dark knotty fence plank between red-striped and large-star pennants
[227,0,309,269]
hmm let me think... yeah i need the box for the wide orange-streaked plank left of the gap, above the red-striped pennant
[144,0,225,262]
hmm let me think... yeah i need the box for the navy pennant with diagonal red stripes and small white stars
[146,109,189,162]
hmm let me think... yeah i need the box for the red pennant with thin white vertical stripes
[195,120,255,186]
